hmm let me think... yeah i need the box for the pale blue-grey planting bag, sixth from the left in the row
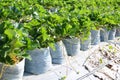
[91,30,100,45]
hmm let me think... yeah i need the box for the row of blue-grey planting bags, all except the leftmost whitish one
[25,29,120,74]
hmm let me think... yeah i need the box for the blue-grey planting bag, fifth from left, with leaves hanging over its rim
[80,35,91,51]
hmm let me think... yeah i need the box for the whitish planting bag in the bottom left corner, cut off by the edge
[0,59,25,80]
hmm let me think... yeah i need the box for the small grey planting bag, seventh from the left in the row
[100,28,109,42]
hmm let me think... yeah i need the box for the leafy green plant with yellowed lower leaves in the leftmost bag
[0,20,29,64]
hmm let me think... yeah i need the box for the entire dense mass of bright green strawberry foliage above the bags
[0,0,120,64]
